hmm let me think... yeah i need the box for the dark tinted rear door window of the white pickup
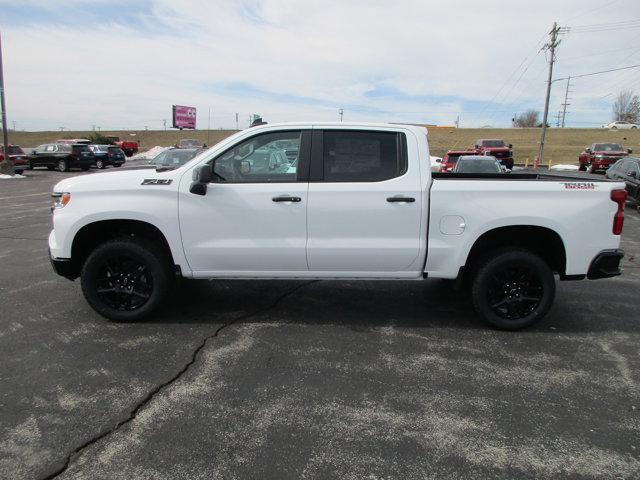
[324,130,407,182]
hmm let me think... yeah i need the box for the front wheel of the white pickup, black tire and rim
[80,237,172,322]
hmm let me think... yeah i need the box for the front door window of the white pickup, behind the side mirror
[213,130,302,183]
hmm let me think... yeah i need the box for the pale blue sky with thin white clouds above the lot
[0,0,640,131]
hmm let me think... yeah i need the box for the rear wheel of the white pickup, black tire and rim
[471,248,556,330]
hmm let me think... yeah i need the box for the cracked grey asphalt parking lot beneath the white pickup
[0,166,640,479]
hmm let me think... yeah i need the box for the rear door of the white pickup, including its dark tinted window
[307,129,426,277]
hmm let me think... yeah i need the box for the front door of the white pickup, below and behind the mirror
[179,130,310,277]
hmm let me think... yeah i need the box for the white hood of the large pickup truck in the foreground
[53,168,183,193]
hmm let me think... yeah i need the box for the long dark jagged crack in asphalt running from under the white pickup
[40,280,320,480]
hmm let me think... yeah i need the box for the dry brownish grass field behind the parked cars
[9,128,640,164]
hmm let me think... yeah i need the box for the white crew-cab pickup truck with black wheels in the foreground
[49,123,626,330]
